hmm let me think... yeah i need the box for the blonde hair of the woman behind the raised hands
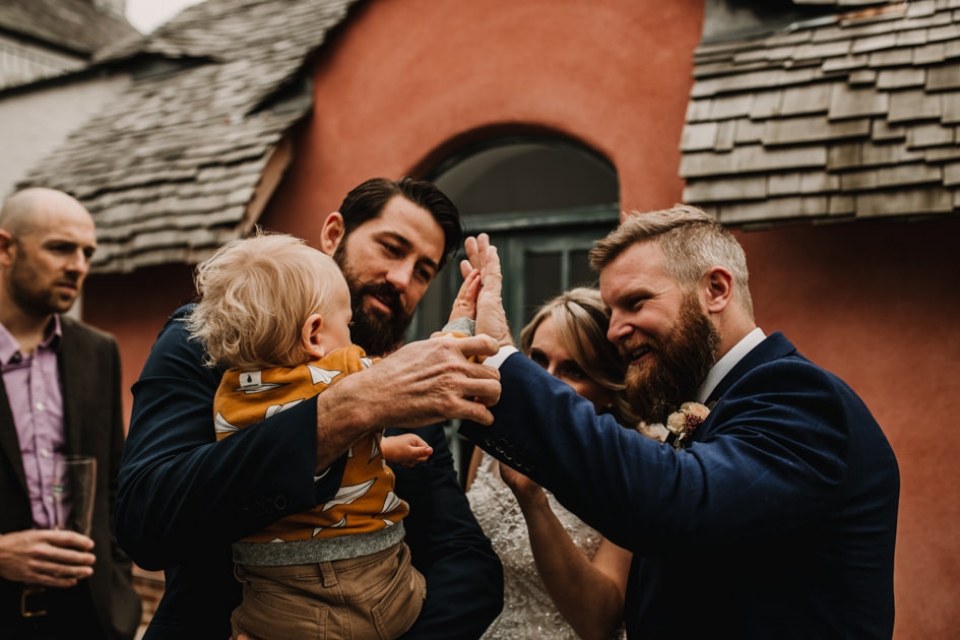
[520,287,639,427]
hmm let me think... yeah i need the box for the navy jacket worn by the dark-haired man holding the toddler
[116,307,503,640]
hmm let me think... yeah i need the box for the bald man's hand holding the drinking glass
[0,529,96,589]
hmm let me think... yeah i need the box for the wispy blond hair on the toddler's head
[186,233,346,369]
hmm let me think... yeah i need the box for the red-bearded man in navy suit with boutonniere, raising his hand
[461,205,900,640]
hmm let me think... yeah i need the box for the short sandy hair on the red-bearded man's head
[590,204,753,317]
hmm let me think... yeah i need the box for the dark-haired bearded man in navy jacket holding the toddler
[116,178,503,640]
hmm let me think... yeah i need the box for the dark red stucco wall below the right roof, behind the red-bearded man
[739,218,960,640]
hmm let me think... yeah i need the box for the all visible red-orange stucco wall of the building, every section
[86,0,960,640]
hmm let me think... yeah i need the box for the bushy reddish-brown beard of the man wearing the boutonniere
[620,295,720,424]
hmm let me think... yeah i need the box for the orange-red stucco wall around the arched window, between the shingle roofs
[264,0,702,239]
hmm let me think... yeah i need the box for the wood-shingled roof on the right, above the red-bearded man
[680,0,960,225]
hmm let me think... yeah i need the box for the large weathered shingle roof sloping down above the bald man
[18,0,354,272]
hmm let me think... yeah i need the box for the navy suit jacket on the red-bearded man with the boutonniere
[461,333,899,640]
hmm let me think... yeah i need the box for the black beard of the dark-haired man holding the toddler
[333,242,413,356]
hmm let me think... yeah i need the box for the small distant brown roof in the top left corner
[0,0,139,57]
